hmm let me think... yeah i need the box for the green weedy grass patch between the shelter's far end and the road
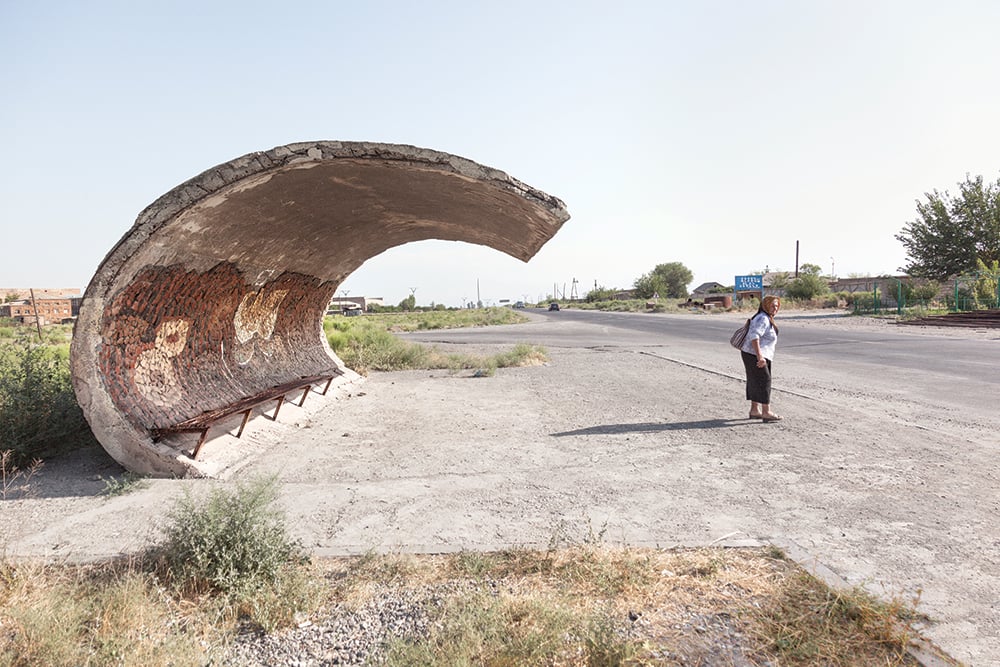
[323,308,547,376]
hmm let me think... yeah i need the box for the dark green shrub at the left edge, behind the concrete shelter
[0,339,95,465]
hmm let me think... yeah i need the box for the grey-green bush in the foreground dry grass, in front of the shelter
[160,477,304,599]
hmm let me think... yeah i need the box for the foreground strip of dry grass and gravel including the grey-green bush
[0,478,918,667]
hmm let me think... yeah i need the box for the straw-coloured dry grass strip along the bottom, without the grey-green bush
[0,544,936,667]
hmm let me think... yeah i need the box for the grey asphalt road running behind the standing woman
[402,309,1000,415]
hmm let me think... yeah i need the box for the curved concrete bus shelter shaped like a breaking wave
[71,141,569,475]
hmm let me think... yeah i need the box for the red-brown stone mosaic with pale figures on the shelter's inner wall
[99,263,337,429]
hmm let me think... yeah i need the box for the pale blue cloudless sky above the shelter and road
[0,0,1000,305]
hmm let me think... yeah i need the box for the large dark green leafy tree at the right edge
[896,175,1000,280]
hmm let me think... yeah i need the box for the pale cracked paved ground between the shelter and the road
[0,316,1000,666]
